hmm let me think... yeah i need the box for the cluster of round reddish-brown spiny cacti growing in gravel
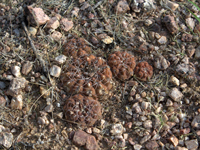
[61,38,153,126]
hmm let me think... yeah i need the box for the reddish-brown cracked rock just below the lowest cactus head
[73,130,99,150]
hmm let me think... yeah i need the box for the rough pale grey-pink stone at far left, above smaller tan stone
[7,77,28,96]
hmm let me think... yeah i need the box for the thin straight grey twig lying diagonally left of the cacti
[22,21,47,73]
